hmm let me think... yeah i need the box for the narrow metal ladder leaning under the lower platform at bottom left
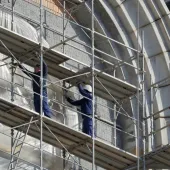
[8,117,33,170]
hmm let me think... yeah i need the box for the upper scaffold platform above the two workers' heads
[0,27,137,101]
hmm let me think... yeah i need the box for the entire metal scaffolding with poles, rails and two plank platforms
[0,0,151,170]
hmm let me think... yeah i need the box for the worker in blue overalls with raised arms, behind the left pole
[16,62,51,117]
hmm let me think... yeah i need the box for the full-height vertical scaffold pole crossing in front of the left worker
[40,0,43,170]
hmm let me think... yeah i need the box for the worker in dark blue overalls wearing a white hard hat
[67,83,93,136]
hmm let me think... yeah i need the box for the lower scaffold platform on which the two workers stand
[0,98,137,170]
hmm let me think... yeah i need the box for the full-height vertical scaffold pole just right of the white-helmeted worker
[91,0,95,170]
